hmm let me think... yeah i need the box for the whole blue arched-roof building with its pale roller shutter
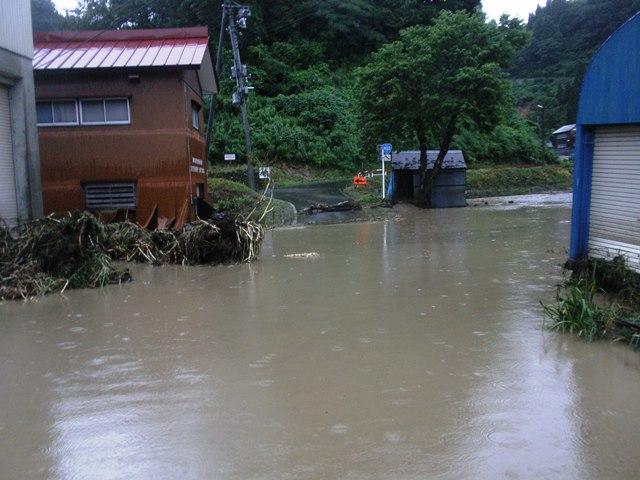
[570,14,640,272]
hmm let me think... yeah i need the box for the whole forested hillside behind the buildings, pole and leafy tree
[32,0,616,169]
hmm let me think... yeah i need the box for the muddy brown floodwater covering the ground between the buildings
[0,201,640,480]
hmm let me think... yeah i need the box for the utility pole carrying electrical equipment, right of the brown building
[223,0,256,190]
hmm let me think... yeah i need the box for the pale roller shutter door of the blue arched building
[589,126,640,271]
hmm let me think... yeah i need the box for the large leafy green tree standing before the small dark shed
[357,12,514,203]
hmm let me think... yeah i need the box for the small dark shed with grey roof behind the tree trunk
[392,150,467,208]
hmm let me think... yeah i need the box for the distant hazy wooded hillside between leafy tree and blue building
[511,0,640,131]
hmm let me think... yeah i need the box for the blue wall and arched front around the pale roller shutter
[570,13,640,260]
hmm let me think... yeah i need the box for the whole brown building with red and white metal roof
[33,27,216,228]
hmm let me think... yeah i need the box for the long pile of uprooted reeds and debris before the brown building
[0,212,264,300]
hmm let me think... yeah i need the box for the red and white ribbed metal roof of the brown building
[33,27,208,70]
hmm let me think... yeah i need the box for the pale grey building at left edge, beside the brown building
[0,1,42,226]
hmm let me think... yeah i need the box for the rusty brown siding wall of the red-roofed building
[36,66,207,228]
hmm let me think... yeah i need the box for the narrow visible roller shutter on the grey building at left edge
[0,85,18,226]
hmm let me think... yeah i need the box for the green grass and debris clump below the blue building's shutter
[544,257,640,347]
